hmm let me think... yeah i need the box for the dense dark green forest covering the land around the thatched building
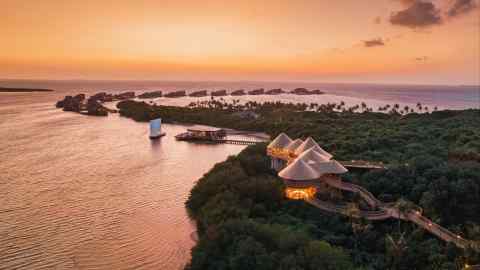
[119,102,480,269]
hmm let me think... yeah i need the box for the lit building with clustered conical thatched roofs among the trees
[267,133,348,199]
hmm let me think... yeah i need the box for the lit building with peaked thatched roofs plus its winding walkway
[267,133,480,250]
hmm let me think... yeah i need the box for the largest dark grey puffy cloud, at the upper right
[390,0,442,28]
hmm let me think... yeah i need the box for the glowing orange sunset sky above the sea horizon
[0,0,480,85]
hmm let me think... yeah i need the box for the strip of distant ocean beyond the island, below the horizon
[0,80,480,110]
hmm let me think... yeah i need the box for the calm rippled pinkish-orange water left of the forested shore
[0,98,248,269]
